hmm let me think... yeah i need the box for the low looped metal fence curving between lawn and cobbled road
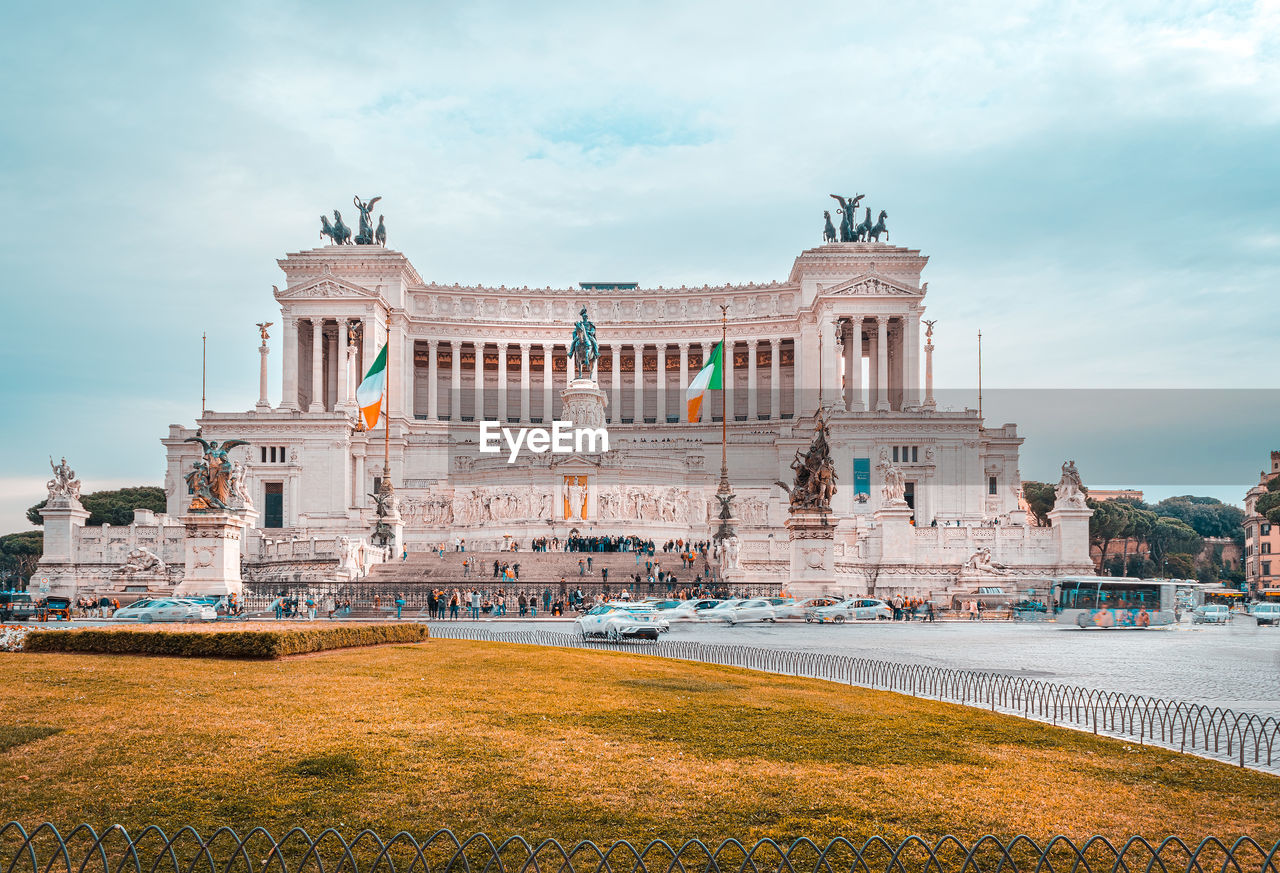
[431,623,1280,771]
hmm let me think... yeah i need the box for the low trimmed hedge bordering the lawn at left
[23,623,429,659]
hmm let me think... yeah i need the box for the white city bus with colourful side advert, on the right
[1053,576,1179,627]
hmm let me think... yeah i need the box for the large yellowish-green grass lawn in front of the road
[0,640,1280,841]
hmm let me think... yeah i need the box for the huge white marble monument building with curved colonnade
[137,234,1091,590]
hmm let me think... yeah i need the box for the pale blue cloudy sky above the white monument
[0,0,1280,533]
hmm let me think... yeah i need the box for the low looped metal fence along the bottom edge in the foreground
[0,822,1280,873]
